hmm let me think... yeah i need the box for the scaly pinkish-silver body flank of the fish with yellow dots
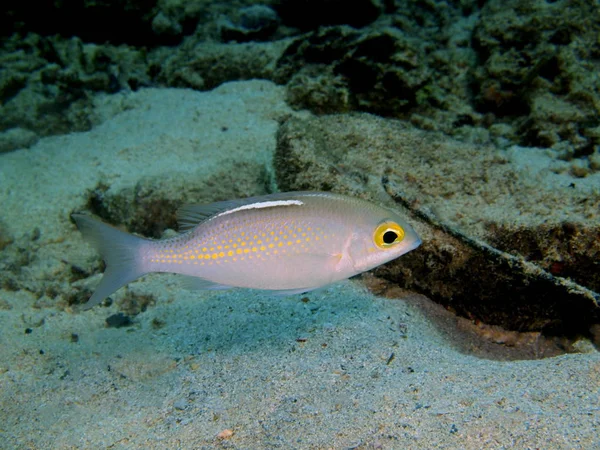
[144,207,345,290]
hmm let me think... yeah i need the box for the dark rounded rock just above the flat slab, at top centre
[275,27,432,116]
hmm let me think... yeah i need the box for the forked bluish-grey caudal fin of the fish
[71,214,146,309]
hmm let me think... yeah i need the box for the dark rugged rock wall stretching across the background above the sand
[0,0,600,167]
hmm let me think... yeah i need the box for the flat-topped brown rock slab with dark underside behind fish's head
[275,115,600,334]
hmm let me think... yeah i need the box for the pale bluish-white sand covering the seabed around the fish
[0,81,600,449]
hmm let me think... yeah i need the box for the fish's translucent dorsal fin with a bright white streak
[176,192,319,233]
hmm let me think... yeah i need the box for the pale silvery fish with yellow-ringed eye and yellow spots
[71,191,421,309]
